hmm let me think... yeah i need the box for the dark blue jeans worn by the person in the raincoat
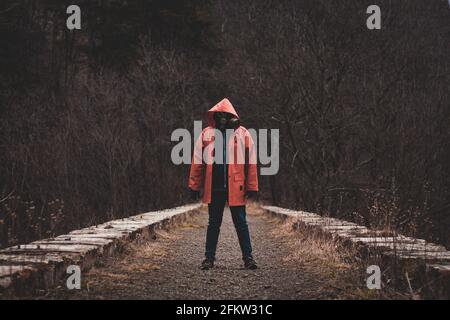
[205,191,252,260]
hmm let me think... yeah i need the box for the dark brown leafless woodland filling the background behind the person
[0,0,450,246]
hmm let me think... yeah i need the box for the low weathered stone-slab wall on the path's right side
[262,206,450,299]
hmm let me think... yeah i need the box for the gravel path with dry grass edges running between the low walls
[35,206,398,299]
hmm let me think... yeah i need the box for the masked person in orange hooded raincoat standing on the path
[189,99,258,270]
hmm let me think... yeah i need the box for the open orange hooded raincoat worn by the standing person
[189,99,258,206]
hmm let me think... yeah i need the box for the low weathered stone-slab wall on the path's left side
[0,203,201,296]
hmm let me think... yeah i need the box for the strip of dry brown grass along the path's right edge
[253,203,410,299]
